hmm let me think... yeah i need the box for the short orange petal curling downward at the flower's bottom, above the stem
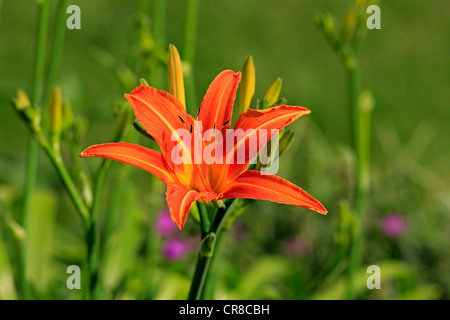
[166,184,219,230]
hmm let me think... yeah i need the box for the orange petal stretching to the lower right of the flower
[223,170,327,214]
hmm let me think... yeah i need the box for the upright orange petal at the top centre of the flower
[198,70,241,132]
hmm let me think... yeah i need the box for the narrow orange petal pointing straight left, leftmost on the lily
[80,142,172,184]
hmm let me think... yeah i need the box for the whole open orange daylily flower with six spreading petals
[80,70,327,229]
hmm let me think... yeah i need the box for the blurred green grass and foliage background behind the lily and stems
[0,0,450,299]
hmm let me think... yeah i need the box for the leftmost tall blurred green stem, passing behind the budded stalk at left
[20,0,49,299]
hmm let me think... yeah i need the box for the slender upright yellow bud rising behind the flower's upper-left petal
[168,44,186,109]
